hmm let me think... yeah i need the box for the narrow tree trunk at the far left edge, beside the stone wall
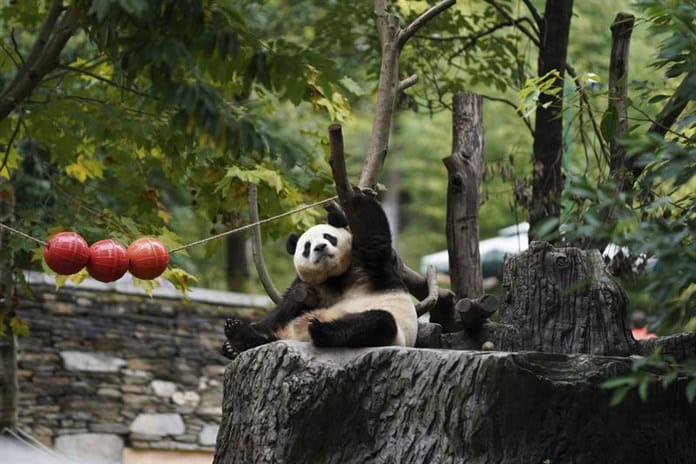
[0,179,17,431]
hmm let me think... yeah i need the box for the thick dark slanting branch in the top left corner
[0,1,79,120]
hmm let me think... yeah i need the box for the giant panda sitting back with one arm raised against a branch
[222,190,418,358]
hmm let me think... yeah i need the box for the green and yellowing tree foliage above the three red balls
[0,0,355,298]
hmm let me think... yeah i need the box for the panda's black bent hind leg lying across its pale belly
[309,309,397,348]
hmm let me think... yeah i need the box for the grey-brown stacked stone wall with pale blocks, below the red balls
[8,273,269,463]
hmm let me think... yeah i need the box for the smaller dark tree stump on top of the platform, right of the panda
[443,242,640,356]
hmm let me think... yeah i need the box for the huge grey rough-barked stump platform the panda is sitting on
[214,342,696,464]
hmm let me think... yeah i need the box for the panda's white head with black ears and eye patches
[286,209,353,284]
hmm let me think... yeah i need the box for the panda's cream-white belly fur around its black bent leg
[276,289,418,346]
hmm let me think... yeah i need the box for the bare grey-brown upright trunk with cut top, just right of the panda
[443,93,483,299]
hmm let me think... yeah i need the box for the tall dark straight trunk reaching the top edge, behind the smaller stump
[529,0,573,240]
